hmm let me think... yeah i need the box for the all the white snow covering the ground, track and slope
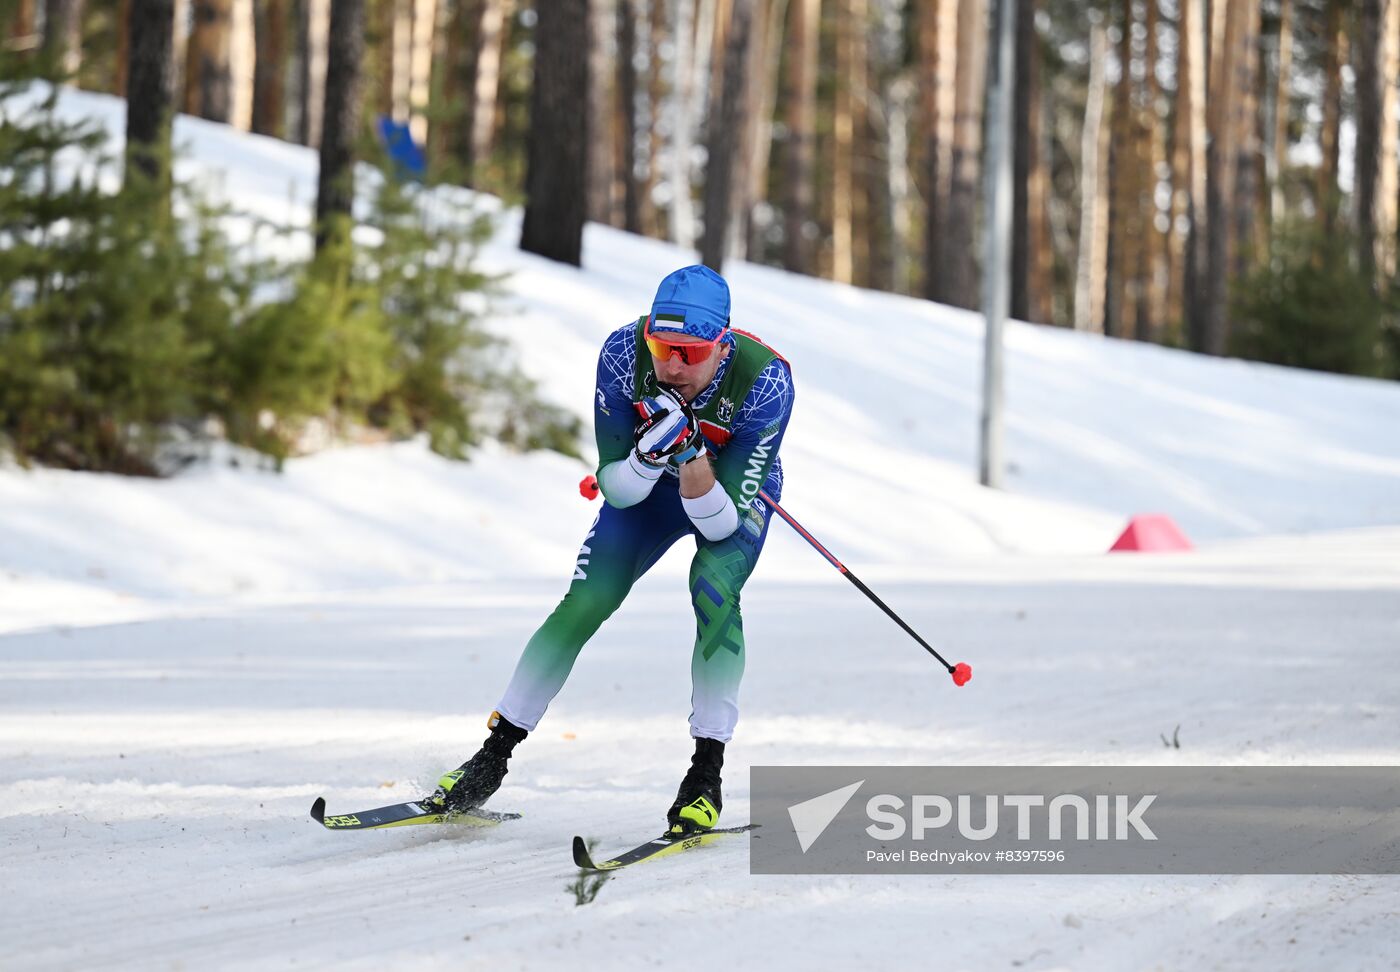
[0,85,1400,969]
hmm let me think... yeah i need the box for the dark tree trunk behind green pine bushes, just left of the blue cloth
[316,0,365,252]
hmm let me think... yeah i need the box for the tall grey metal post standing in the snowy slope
[981,0,1018,489]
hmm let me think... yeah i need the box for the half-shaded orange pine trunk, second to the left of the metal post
[918,0,958,301]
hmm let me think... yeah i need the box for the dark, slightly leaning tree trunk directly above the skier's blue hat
[700,0,753,273]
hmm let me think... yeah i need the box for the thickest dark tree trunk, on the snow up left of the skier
[521,0,588,266]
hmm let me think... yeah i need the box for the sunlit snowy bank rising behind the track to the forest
[0,92,1400,605]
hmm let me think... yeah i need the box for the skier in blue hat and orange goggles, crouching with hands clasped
[428,266,794,836]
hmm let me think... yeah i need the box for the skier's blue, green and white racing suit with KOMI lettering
[497,318,794,742]
